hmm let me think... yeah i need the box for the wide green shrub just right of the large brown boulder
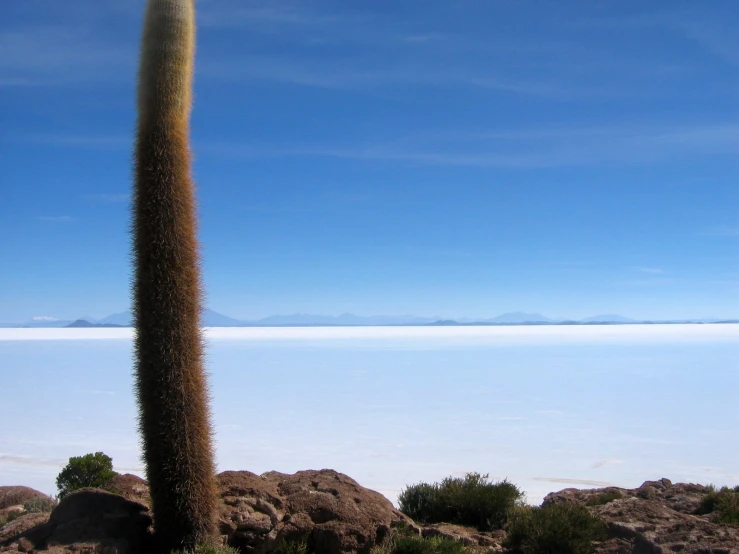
[398,473,523,531]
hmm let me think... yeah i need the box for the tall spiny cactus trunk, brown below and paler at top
[133,0,216,552]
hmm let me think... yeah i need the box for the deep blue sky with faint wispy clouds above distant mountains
[0,0,739,322]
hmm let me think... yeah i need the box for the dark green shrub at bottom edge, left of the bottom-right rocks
[503,503,608,554]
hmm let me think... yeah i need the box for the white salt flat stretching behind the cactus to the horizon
[0,324,739,502]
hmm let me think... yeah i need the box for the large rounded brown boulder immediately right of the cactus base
[218,469,417,554]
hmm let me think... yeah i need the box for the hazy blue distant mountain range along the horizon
[0,309,739,328]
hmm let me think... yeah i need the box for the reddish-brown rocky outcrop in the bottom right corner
[543,479,739,554]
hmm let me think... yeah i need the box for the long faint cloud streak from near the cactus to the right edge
[201,123,739,168]
